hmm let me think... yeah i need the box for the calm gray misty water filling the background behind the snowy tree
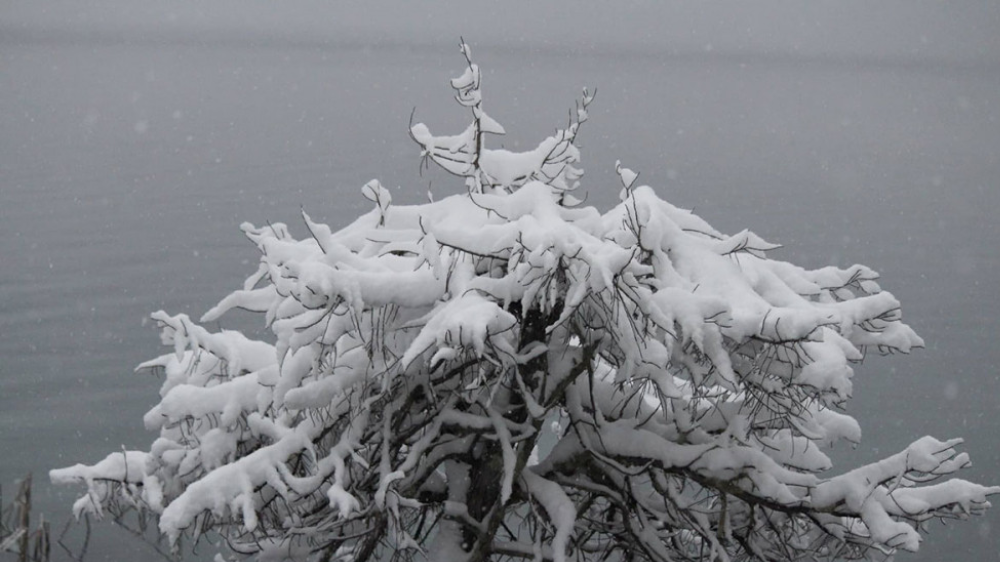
[0,0,1000,561]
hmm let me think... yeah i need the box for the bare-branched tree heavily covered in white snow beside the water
[51,44,1000,562]
